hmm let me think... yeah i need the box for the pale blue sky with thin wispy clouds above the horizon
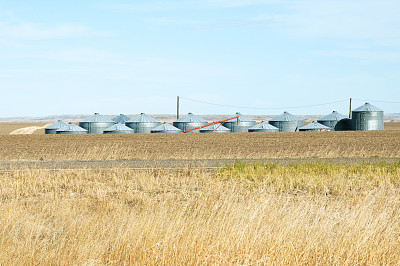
[0,0,400,117]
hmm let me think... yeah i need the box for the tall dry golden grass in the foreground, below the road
[0,163,400,265]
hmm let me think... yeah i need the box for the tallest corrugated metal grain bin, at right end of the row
[351,103,384,130]
